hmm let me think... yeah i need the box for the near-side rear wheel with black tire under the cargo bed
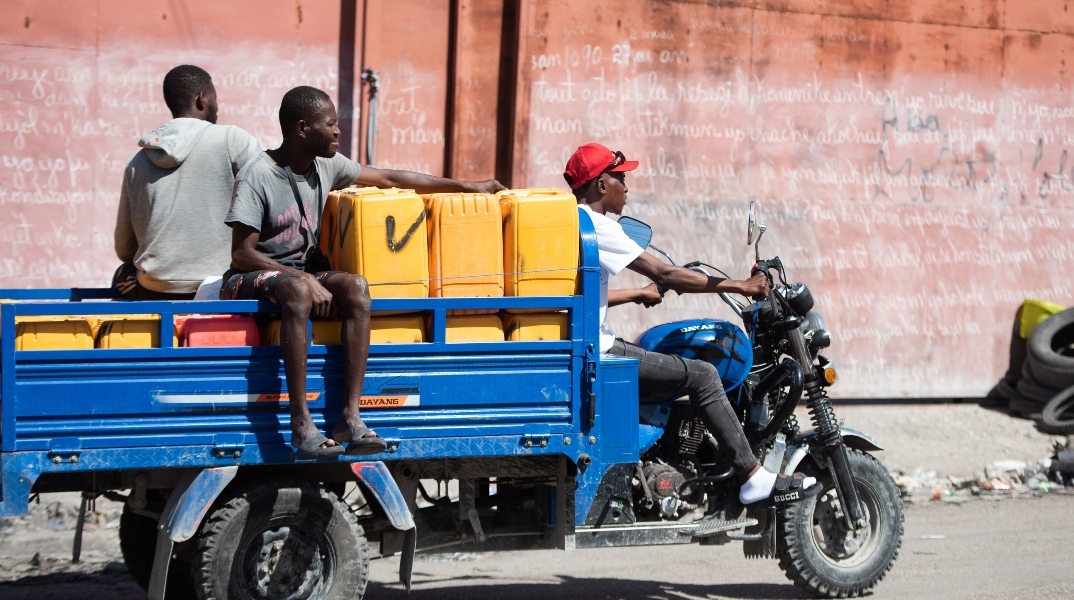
[193,479,369,600]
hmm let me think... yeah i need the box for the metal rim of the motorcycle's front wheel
[809,481,886,569]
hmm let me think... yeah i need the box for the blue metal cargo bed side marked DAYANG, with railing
[0,211,638,522]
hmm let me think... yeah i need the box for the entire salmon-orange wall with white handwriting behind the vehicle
[0,0,1074,396]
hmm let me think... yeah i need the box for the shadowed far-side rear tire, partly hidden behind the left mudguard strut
[119,506,198,600]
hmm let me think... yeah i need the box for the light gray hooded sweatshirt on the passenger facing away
[115,118,264,294]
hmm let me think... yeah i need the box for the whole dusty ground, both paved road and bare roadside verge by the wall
[0,403,1074,600]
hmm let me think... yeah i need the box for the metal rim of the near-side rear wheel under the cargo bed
[235,518,336,600]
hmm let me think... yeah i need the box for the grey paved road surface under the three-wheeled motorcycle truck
[0,495,1074,600]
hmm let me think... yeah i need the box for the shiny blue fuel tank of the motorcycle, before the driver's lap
[635,319,753,392]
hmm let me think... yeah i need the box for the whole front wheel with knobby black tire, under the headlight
[777,449,903,598]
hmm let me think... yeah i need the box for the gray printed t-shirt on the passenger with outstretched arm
[223,152,362,268]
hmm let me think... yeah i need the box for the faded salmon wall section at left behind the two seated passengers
[0,0,340,287]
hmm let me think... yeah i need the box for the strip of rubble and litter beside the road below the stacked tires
[890,436,1074,503]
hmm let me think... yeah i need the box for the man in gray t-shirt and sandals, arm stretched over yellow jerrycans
[220,86,504,459]
